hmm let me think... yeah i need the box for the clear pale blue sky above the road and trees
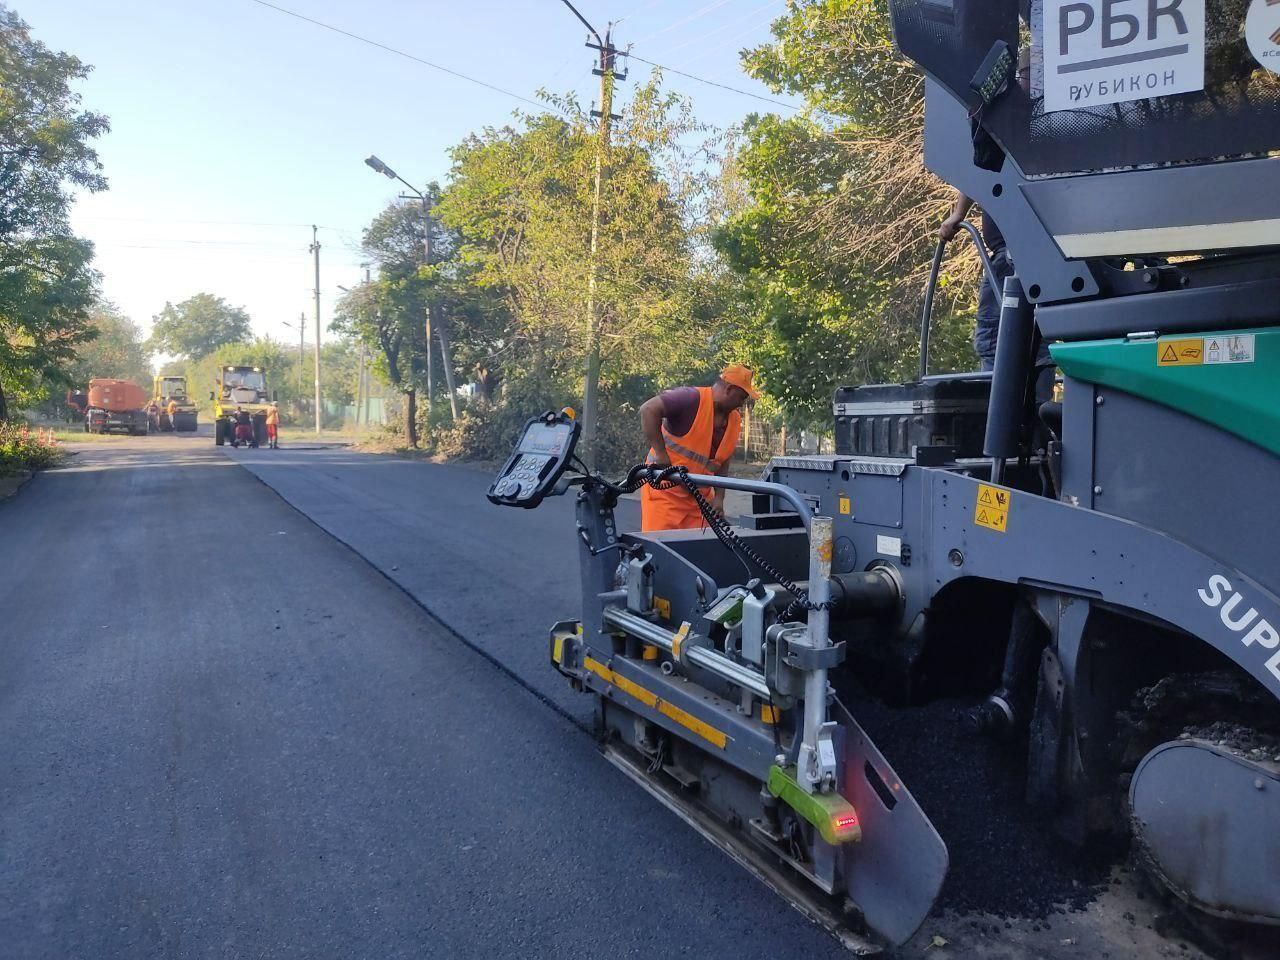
[24,0,785,353]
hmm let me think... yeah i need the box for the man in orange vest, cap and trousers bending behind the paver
[640,364,759,531]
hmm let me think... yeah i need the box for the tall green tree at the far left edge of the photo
[0,6,108,420]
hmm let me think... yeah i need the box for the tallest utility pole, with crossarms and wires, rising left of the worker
[562,0,626,470]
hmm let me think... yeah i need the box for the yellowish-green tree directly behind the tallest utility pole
[440,76,718,440]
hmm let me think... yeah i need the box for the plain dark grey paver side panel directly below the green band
[1094,390,1280,593]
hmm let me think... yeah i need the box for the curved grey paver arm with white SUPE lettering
[911,468,1280,698]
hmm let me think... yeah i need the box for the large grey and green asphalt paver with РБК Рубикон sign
[490,0,1280,943]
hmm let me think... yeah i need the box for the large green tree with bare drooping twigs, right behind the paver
[717,0,977,426]
